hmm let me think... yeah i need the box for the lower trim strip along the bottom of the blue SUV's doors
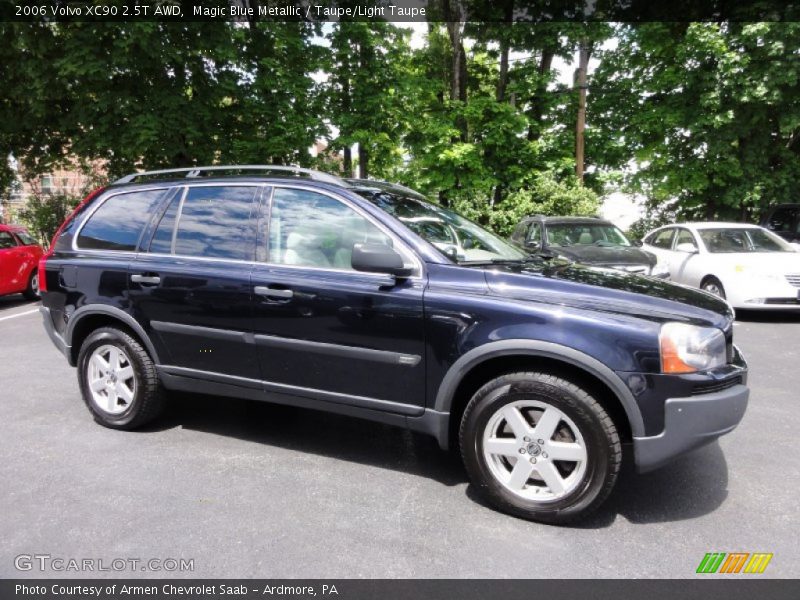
[158,365,425,416]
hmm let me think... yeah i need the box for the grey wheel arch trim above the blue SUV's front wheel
[433,339,645,436]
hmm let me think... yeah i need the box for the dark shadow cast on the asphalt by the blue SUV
[142,394,728,529]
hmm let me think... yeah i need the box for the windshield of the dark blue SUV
[354,190,528,263]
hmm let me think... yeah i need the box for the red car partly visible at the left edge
[0,225,44,300]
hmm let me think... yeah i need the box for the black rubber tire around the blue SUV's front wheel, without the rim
[459,373,622,523]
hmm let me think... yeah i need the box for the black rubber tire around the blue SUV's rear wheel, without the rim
[78,327,165,430]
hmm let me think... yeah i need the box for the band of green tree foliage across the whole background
[0,18,800,233]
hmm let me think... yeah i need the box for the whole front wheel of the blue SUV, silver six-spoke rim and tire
[459,373,622,523]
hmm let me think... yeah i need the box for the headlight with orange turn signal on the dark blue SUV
[659,323,728,373]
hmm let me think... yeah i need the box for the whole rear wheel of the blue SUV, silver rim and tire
[78,327,164,429]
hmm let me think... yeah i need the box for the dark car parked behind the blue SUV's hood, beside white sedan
[511,215,669,278]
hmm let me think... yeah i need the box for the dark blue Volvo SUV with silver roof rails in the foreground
[39,166,748,523]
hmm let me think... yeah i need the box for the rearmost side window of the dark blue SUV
[77,190,164,251]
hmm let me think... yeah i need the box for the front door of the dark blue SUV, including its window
[252,186,425,414]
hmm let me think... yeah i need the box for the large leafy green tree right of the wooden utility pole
[589,22,800,220]
